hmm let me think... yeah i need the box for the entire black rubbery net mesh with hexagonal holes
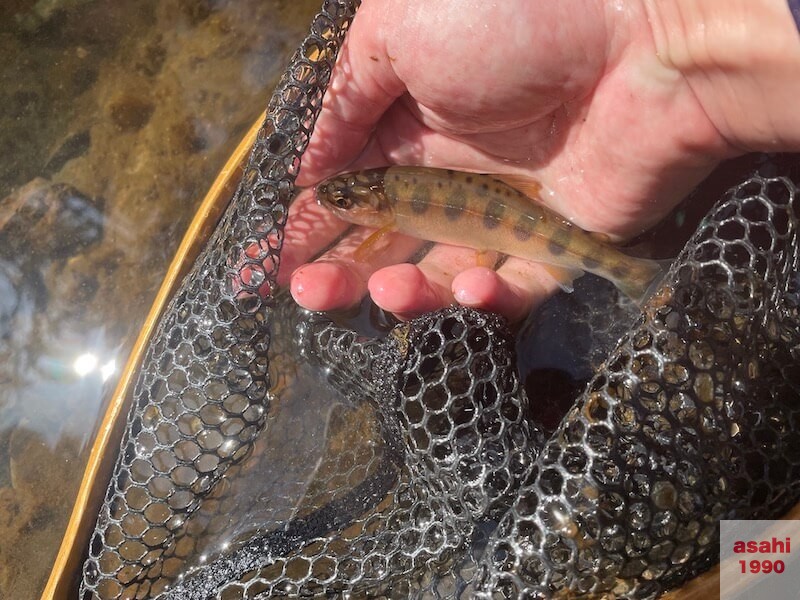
[81,1,800,600]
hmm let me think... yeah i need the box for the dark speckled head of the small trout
[315,172,394,228]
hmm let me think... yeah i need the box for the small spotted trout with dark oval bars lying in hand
[316,167,664,303]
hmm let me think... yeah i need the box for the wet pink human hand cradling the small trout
[279,0,800,319]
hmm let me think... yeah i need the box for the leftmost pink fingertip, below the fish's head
[289,262,366,310]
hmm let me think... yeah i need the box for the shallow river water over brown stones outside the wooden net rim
[0,0,318,598]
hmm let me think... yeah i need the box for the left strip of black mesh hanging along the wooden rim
[81,0,357,598]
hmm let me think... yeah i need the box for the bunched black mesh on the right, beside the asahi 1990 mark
[482,176,800,598]
